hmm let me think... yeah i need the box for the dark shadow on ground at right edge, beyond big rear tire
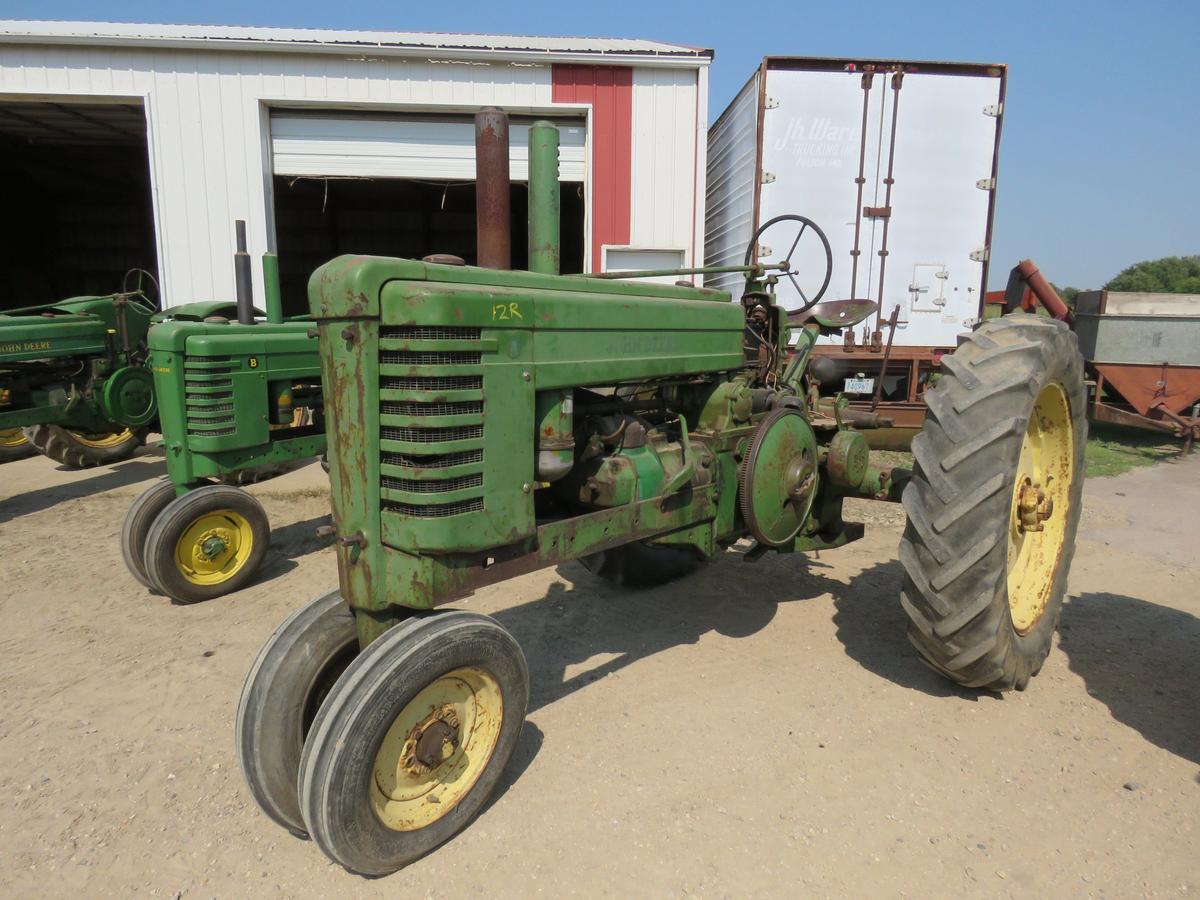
[1058,593,1200,763]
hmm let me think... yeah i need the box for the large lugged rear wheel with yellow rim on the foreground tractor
[900,314,1087,691]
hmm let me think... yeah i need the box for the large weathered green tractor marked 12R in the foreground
[236,113,1086,875]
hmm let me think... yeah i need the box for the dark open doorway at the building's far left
[0,100,158,310]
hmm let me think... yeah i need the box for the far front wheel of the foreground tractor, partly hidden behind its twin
[235,590,359,835]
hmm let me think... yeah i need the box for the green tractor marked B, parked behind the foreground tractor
[121,222,325,602]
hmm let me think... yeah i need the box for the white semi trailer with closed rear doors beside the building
[704,56,1007,425]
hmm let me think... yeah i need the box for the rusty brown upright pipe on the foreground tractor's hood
[475,107,512,269]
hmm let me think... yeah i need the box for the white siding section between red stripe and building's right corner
[629,68,704,265]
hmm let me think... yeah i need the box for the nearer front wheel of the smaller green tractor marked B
[143,485,271,604]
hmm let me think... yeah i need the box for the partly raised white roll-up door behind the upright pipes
[271,109,584,181]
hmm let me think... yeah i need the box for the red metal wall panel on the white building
[551,65,634,272]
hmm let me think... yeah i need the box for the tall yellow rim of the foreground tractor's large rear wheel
[1008,384,1075,635]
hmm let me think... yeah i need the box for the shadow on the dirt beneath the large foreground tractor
[484,550,974,713]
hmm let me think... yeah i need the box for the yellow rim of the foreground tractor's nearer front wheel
[368,666,504,832]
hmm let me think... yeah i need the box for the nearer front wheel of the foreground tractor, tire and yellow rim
[300,611,529,875]
